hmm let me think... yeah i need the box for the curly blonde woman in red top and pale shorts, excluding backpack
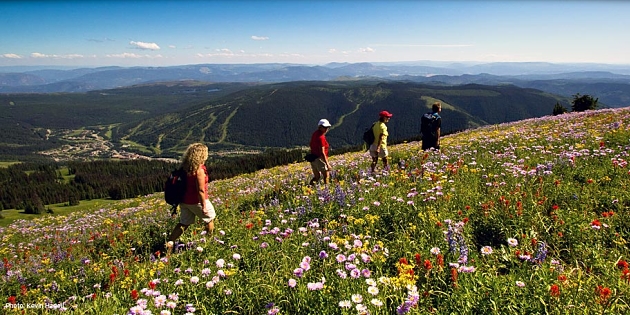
[166,143,217,254]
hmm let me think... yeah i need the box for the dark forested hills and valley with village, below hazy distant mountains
[0,80,569,161]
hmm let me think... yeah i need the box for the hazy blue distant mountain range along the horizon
[0,61,630,107]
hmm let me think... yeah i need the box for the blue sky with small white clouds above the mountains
[0,0,630,66]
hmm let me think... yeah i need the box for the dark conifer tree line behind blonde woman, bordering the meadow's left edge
[0,149,304,213]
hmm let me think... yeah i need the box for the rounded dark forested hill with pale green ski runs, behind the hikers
[114,81,568,156]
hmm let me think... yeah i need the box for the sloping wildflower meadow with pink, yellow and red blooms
[0,108,630,315]
